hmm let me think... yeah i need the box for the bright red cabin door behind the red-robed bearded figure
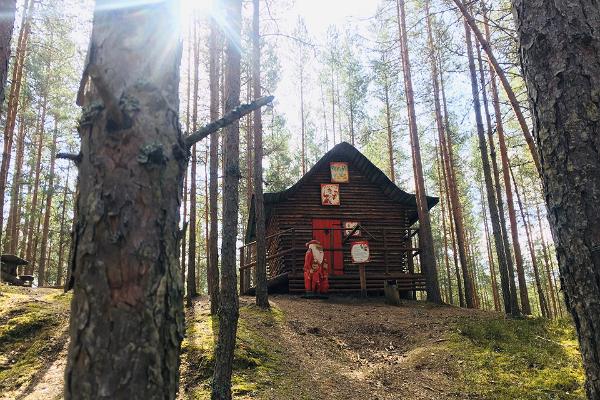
[313,219,344,275]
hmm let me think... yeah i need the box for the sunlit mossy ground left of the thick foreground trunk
[0,285,70,394]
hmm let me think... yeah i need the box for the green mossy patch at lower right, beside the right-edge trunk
[448,318,585,400]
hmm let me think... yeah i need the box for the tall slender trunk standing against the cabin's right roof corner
[396,0,442,303]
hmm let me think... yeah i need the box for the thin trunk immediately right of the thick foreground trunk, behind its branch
[185,16,200,307]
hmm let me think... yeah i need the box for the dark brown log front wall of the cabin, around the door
[268,155,415,276]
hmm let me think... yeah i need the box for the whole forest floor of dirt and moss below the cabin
[0,286,585,400]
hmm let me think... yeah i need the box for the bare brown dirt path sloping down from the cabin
[260,296,489,400]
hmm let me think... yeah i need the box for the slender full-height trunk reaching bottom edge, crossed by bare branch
[212,0,242,400]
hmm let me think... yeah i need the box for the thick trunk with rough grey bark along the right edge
[512,0,600,399]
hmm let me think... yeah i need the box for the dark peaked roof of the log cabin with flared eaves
[246,142,439,242]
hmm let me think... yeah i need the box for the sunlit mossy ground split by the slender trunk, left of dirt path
[182,305,283,399]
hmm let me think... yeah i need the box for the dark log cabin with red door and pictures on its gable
[239,142,438,295]
